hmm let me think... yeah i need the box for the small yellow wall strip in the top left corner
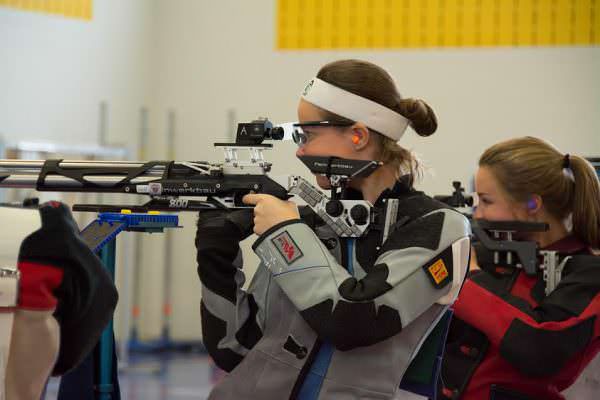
[0,0,94,21]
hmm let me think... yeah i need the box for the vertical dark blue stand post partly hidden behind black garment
[97,238,117,400]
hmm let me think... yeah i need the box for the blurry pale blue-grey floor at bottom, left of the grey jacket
[45,353,222,400]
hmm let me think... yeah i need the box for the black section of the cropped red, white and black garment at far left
[19,202,118,375]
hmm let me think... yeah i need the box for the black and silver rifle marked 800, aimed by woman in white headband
[0,119,395,237]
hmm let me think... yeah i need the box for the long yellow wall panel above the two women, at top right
[276,0,600,49]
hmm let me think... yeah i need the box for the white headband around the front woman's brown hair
[302,78,410,141]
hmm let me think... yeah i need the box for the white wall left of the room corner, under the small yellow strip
[0,0,155,145]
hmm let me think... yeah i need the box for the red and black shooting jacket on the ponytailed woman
[439,236,600,400]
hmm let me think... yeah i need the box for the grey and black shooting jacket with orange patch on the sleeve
[196,181,470,400]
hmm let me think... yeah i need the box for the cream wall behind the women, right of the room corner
[144,0,600,337]
